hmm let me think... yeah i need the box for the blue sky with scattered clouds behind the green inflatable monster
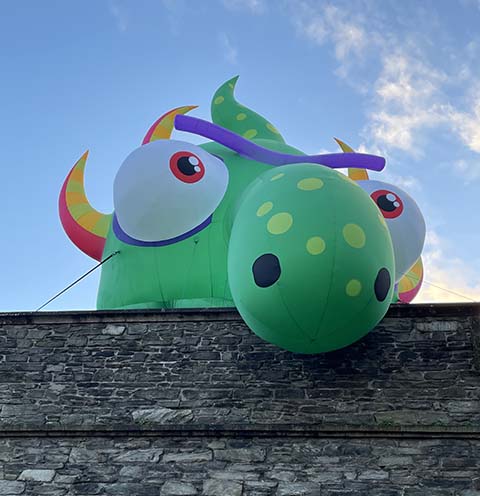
[0,0,480,311]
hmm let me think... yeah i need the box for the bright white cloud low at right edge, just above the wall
[415,230,480,303]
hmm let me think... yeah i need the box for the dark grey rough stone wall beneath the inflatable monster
[0,305,480,496]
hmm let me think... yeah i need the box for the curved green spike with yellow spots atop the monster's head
[212,76,285,143]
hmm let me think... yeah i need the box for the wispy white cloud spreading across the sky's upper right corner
[286,0,480,168]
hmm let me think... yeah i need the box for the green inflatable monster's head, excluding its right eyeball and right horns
[59,78,402,353]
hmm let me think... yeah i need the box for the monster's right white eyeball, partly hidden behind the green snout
[358,181,426,282]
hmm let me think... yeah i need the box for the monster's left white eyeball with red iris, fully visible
[113,140,228,242]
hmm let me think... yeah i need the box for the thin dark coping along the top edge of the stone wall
[0,302,480,325]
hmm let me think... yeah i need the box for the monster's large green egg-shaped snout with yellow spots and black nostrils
[228,164,394,353]
